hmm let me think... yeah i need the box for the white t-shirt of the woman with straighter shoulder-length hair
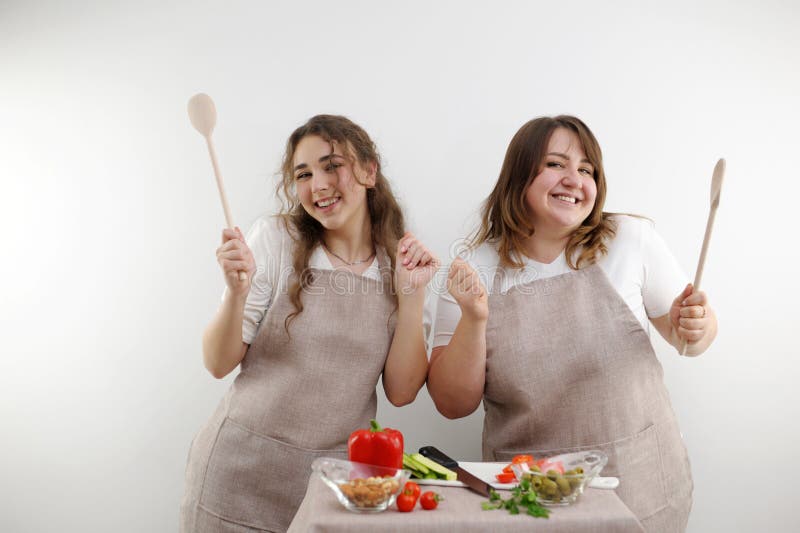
[433,215,688,348]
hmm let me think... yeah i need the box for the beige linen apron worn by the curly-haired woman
[181,253,396,533]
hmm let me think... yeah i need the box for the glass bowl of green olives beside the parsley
[511,450,608,506]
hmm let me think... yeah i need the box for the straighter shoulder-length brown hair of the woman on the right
[471,115,616,270]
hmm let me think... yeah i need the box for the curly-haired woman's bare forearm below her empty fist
[383,290,428,407]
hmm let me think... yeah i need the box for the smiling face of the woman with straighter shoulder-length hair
[525,128,597,237]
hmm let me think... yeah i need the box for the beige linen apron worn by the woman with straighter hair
[483,265,693,532]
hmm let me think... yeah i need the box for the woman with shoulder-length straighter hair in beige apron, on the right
[428,116,717,532]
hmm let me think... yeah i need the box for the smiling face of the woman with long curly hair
[292,135,375,236]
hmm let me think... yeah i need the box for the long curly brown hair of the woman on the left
[276,115,405,332]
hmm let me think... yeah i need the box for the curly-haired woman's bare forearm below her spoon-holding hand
[203,292,247,379]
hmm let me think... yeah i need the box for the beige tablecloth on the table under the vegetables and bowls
[289,475,644,533]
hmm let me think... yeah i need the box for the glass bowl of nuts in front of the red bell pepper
[311,457,411,513]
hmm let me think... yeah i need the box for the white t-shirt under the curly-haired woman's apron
[222,215,433,345]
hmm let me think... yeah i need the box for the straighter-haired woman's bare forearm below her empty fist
[428,315,486,418]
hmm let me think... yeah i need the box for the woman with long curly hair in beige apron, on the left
[181,115,437,533]
